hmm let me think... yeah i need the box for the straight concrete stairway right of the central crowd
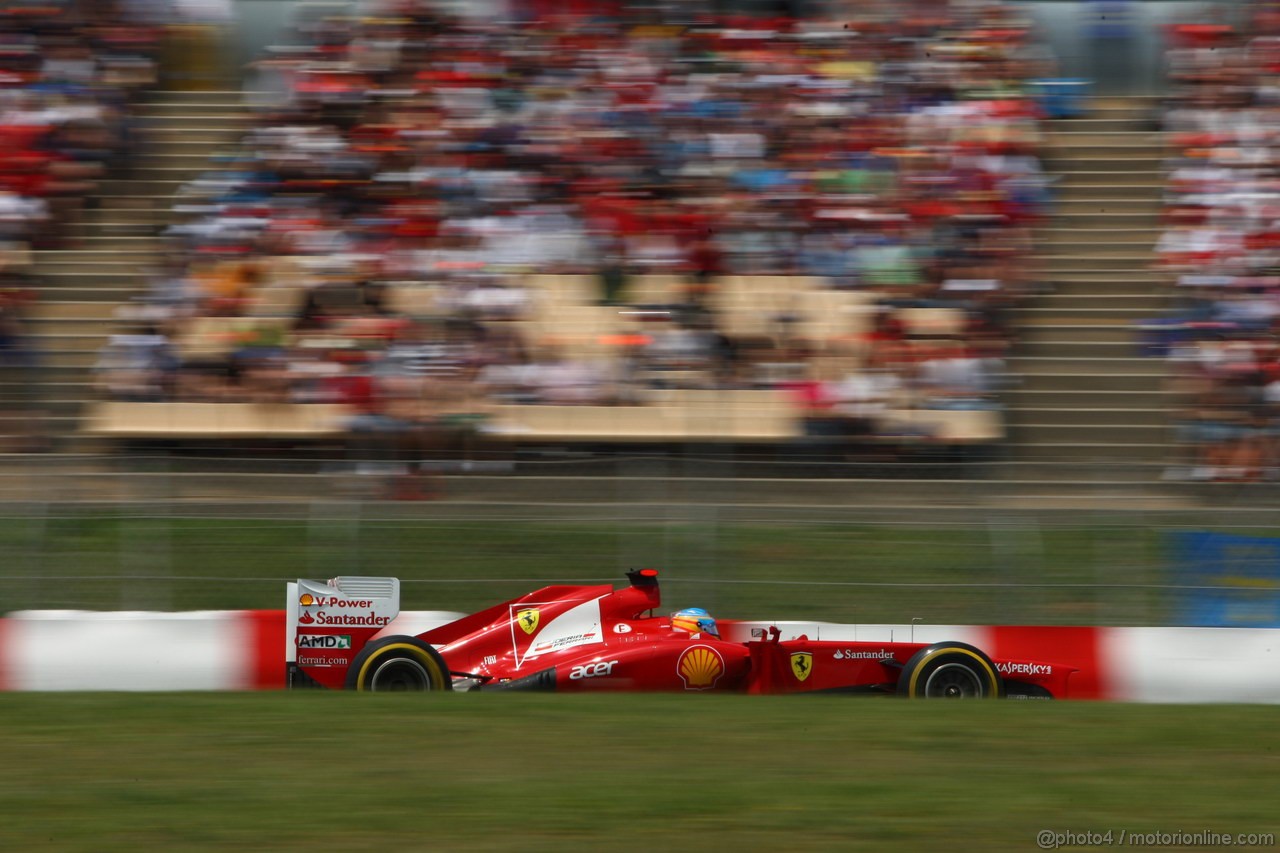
[1009,99,1171,485]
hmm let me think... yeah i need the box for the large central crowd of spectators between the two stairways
[101,0,1050,466]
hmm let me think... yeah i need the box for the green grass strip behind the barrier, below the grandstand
[0,515,1174,625]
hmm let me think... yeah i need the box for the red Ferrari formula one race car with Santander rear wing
[285,569,1074,698]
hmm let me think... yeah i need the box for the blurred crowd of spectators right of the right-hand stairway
[1151,14,1280,480]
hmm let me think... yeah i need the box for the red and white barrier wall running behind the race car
[0,611,1280,703]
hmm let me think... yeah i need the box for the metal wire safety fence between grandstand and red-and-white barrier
[0,456,1276,625]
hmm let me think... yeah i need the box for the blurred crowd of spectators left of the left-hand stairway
[0,0,163,450]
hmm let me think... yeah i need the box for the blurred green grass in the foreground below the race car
[0,693,1280,850]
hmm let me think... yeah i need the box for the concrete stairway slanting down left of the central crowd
[15,91,247,444]
